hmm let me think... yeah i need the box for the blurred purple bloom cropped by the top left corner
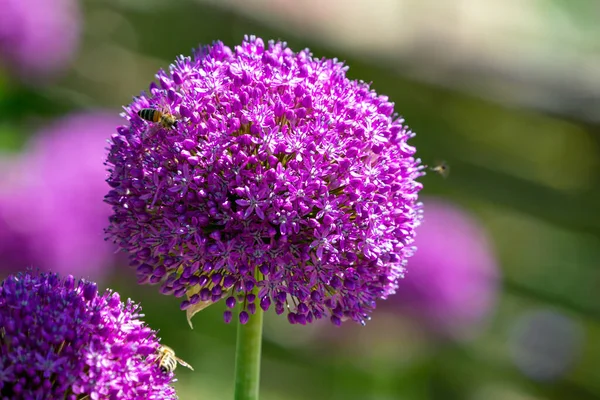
[0,0,81,78]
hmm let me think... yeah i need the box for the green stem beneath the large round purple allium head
[234,307,263,400]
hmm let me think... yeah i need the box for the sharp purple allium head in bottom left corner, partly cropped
[0,272,177,400]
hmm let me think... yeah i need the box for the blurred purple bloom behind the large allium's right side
[391,198,499,339]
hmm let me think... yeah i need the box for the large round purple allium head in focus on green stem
[106,37,423,324]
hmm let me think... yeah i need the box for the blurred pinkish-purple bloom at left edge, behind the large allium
[0,112,119,280]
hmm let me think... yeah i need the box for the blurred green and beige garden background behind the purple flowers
[0,0,600,400]
